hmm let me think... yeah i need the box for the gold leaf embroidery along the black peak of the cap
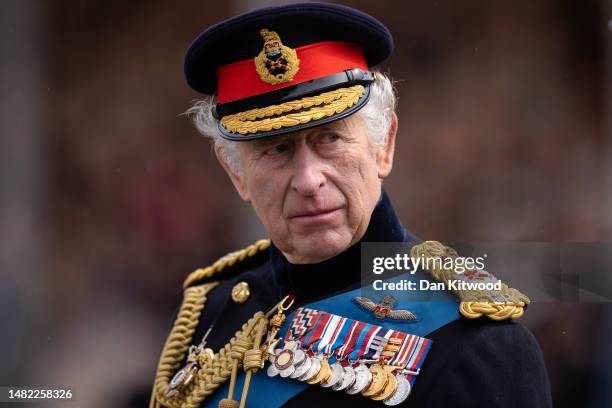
[221,85,365,135]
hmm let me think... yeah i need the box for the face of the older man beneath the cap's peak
[224,115,396,263]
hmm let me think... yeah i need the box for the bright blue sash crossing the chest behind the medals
[203,271,459,408]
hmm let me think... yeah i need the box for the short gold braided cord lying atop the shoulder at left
[183,239,270,289]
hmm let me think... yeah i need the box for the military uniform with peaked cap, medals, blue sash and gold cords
[151,4,551,407]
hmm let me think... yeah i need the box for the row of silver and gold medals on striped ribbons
[270,308,431,406]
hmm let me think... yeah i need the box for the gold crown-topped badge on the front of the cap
[255,28,300,85]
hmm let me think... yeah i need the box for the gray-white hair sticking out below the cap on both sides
[185,72,397,173]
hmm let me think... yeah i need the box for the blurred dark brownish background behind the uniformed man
[0,0,612,408]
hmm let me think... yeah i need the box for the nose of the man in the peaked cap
[291,143,325,196]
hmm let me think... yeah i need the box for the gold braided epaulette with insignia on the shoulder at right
[410,241,530,320]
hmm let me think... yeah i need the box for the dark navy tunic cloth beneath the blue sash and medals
[180,192,551,408]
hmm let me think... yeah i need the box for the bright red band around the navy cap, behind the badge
[217,41,368,103]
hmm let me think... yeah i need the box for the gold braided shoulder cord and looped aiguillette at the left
[149,240,270,408]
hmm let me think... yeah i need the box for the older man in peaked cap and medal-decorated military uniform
[151,3,551,407]
